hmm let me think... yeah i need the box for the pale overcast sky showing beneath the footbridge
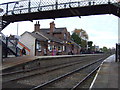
[0,0,118,48]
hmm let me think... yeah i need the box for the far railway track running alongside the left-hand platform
[2,54,104,83]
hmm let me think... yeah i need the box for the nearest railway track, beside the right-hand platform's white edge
[30,59,103,90]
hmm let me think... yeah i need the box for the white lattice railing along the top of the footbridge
[0,0,120,16]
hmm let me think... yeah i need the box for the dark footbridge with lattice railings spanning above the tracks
[0,0,120,30]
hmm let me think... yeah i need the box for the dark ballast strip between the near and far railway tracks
[3,56,109,89]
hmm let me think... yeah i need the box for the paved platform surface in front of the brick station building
[0,55,85,70]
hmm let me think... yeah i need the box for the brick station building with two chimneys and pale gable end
[19,22,81,56]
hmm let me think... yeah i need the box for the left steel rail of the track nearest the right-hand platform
[30,58,103,90]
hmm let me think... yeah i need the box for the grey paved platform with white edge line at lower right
[90,55,120,89]
